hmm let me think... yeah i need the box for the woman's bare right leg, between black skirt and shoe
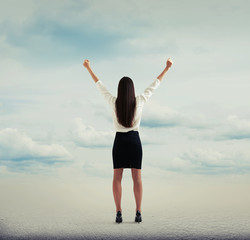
[131,168,142,212]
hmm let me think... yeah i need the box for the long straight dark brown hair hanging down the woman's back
[115,77,136,127]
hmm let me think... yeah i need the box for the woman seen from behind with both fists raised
[83,58,172,223]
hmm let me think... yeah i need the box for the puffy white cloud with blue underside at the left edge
[0,128,72,164]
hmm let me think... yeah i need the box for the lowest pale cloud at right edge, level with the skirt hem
[151,148,250,175]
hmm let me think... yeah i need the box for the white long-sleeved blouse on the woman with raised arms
[96,78,161,132]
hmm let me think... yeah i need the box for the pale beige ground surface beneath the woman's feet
[0,176,250,239]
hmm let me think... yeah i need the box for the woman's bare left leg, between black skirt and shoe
[113,168,123,212]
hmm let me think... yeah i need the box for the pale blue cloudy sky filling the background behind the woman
[0,0,250,227]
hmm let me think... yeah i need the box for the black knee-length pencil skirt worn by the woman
[112,130,143,169]
